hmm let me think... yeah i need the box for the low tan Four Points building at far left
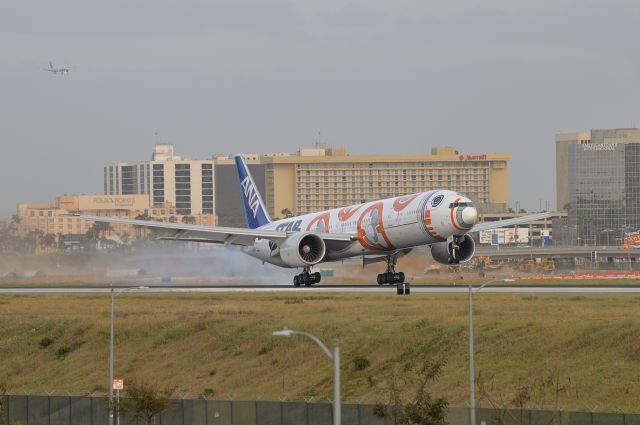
[17,195,214,240]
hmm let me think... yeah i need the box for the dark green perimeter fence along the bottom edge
[0,395,640,425]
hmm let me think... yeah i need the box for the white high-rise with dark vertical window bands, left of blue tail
[104,145,215,219]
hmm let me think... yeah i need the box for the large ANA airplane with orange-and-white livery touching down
[73,155,549,287]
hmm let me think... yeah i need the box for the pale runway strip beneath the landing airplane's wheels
[0,285,640,296]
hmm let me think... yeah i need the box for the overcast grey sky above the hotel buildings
[0,0,640,216]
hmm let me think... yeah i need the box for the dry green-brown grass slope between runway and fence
[0,292,640,411]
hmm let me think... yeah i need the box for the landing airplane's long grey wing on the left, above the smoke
[71,214,357,246]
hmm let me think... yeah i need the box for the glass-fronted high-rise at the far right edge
[554,128,640,245]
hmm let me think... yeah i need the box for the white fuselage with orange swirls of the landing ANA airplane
[244,190,477,267]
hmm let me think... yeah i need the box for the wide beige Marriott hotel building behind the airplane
[261,146,511,217]
